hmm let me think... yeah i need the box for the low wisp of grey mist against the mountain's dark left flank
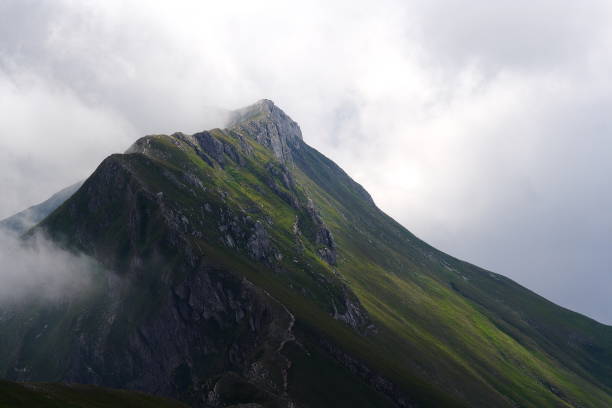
[0,231,96,305]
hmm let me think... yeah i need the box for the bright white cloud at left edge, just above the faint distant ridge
[0,75,137,218]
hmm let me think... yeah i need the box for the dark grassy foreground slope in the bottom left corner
[0,381,186,408]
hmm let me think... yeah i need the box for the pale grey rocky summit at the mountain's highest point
[226,99,303,164]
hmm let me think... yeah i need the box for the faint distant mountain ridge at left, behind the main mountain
[0,181,83,234]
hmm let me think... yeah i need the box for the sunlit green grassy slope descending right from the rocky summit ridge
[290,142,612,407]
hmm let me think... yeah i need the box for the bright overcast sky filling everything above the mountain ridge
[0,0,612,323]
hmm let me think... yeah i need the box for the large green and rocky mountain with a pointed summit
[0,100,612,408]
